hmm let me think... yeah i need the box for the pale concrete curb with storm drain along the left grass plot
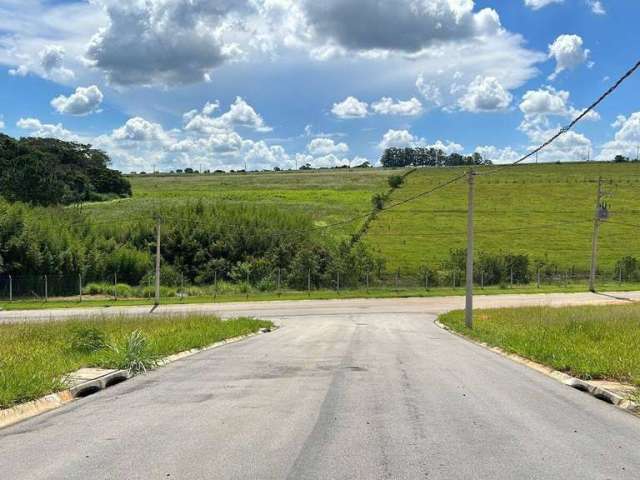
[0,326,272,430]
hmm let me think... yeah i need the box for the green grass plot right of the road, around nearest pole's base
[440,304,640,386]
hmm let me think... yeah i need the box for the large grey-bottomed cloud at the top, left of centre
[87,0,248,85]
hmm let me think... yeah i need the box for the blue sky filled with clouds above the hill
[0,0,640,172]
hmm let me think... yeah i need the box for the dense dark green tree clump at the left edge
[0,134,131,205]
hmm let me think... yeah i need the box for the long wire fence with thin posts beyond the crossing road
[0,269,640,302]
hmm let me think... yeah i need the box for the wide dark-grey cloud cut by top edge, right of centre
[302,0,499,52]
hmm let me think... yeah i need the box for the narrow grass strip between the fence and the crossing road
[0,282,640,312]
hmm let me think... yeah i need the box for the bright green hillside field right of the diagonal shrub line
[365,163,640,274]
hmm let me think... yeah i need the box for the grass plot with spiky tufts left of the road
[0,315,272,409]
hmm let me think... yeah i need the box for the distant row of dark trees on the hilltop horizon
[380,147,491,168]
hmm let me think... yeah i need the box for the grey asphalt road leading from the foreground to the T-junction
[0,296,640,480]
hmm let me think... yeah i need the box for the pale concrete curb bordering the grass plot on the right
[434,320,640,416]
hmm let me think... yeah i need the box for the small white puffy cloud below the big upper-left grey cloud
[183,97,273,133]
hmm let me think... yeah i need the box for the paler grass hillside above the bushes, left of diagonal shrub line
[85,169,393,235]
